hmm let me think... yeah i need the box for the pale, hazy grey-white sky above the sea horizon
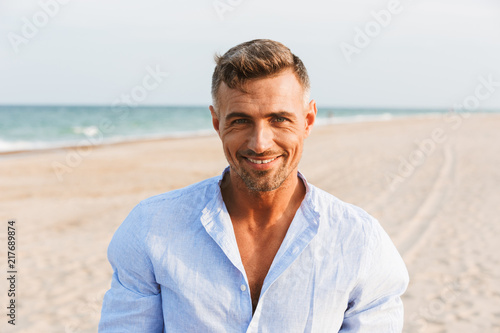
[0,0,500,109]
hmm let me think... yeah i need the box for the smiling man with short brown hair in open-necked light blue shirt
[99,40,408,333]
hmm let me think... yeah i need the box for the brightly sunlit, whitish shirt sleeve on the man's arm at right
[339,221,409,333]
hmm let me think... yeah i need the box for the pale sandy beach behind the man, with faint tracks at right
[0,114,500,333]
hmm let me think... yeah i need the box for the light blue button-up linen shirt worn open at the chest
[99,169,408,333]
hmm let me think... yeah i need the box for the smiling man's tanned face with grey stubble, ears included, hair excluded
[210,70,316,191]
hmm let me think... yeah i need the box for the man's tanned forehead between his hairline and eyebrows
[219,70,304,113]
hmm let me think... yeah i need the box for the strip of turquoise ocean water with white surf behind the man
[0,106,484,153]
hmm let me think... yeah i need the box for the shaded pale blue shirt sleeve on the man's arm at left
[99,204,163,333]
